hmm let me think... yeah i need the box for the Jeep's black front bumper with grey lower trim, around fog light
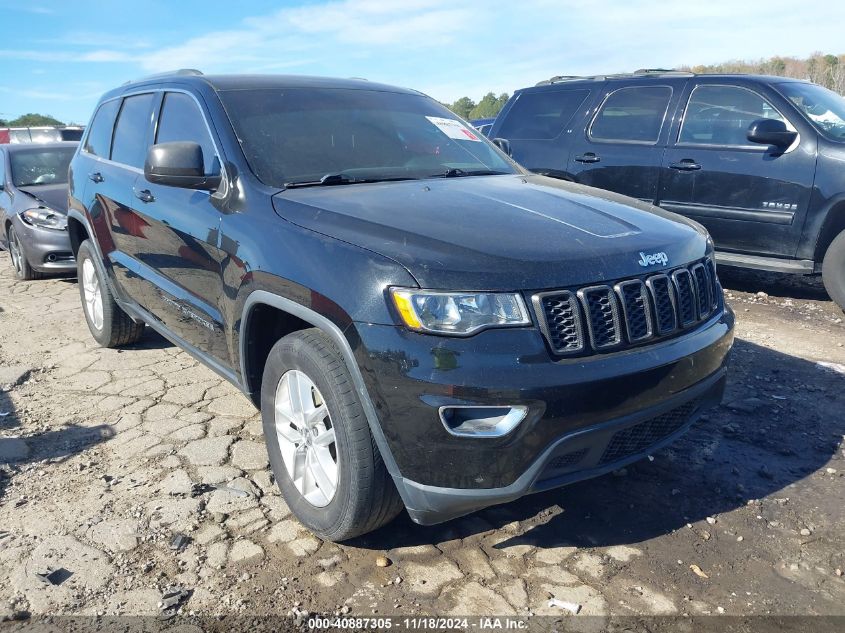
[350,308,734,524]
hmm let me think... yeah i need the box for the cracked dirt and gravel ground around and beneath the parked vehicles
[0,253,845,621]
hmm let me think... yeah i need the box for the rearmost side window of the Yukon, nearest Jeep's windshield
[499,90,590,140]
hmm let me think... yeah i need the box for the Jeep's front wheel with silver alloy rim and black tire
[261,329,402,541]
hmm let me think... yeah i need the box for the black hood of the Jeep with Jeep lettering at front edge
[273,175,707,290]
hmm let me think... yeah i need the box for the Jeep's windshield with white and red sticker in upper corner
[220,88,517,187]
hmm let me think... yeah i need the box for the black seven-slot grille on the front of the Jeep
[532,258,721,356]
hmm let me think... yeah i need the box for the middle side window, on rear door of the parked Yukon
[590,86,672,143]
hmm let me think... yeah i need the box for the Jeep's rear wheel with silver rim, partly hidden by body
[76,240,144,347]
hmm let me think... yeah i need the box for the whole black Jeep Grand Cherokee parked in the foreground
[69,71,733,540]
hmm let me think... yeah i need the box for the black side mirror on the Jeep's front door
[144,141,220,191]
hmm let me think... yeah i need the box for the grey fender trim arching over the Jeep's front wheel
[239,290,409,506]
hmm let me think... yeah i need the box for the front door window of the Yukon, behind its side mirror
[678,86,794,147]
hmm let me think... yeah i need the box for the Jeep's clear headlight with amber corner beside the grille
[390,288,531,336]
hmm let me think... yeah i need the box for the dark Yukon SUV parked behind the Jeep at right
[489,71,845,308]
